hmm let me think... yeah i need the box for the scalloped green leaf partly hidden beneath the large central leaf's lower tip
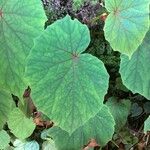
[43,106,115,150]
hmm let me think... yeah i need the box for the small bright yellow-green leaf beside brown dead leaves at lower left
[7,108,35,140]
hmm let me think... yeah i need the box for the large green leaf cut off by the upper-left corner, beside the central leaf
[0,0,46,96]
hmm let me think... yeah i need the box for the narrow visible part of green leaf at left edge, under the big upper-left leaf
[0,90,12,130]
